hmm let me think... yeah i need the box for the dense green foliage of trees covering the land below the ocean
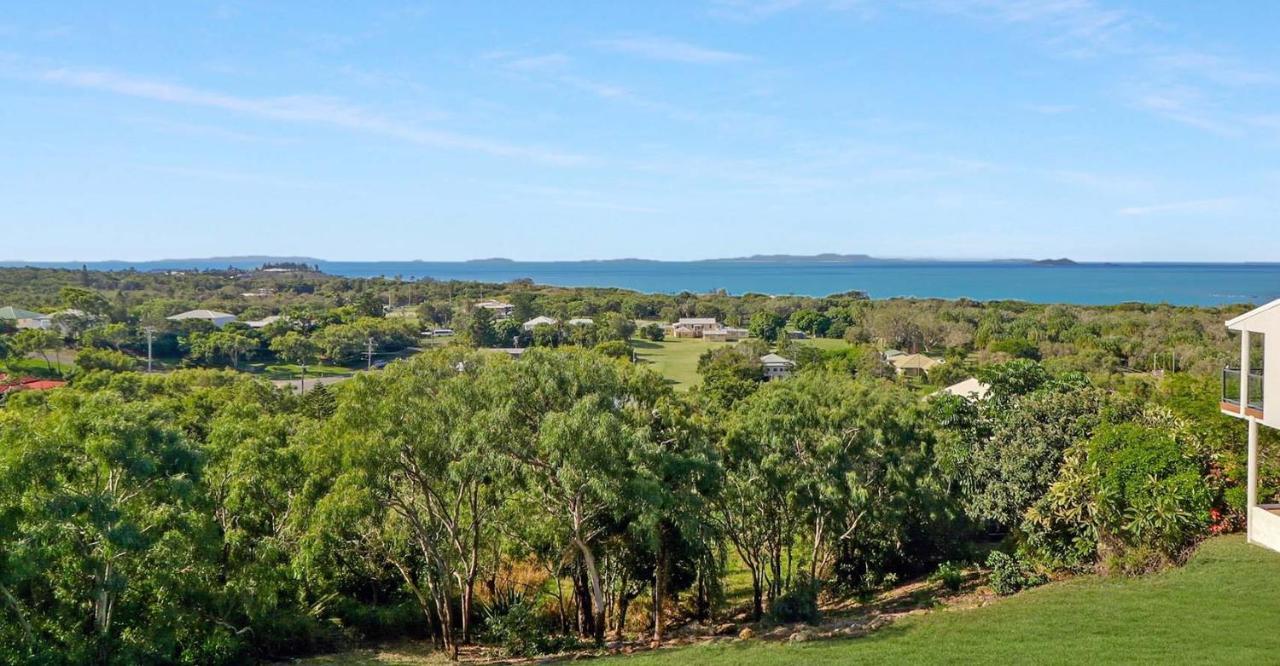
[0,270,1264,663]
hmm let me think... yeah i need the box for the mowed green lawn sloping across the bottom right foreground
[605,535,1280,666]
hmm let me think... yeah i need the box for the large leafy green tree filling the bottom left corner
[0,391,202,662]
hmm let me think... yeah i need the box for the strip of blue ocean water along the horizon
[6,259,1280,305]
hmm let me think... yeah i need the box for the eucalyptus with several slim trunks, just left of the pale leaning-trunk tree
[310,350,509,656]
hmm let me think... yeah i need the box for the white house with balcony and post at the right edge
[1221,298,1280,551]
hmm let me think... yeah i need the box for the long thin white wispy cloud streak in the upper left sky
[27,68,588,165]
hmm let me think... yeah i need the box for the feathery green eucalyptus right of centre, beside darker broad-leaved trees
[713,373,933,616]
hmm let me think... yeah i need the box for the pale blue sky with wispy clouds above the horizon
[0,0,1280,261]
